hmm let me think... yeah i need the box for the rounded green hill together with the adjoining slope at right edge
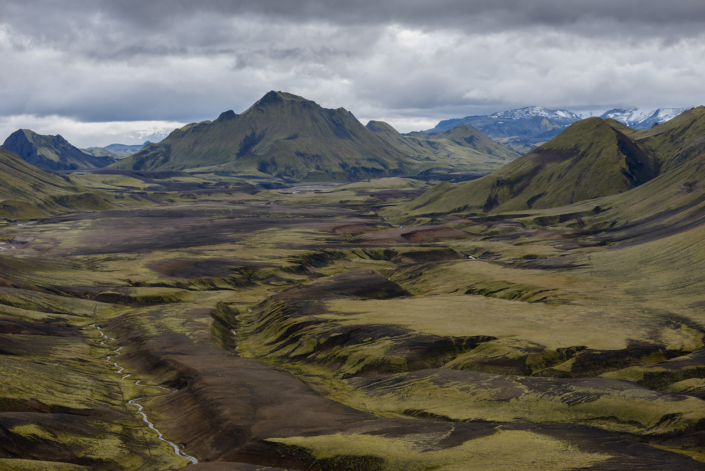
[398,106,705,220]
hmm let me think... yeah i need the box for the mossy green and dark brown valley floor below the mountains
[0,160,705,470]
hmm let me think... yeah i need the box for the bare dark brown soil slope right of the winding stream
[102,318,702,470]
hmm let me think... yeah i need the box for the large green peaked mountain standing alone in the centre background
[113,91,513,181]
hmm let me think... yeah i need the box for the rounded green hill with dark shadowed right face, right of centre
[398,118,660,216]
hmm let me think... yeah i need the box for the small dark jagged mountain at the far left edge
[2,129,114,170]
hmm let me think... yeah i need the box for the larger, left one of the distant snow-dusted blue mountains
[423,106,580,153]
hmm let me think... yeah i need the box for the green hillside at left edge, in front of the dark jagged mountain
[0,148,118,220]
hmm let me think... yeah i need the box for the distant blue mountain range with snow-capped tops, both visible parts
[422,106,687,153]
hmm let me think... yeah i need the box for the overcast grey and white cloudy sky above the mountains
[0,0,705,147]
